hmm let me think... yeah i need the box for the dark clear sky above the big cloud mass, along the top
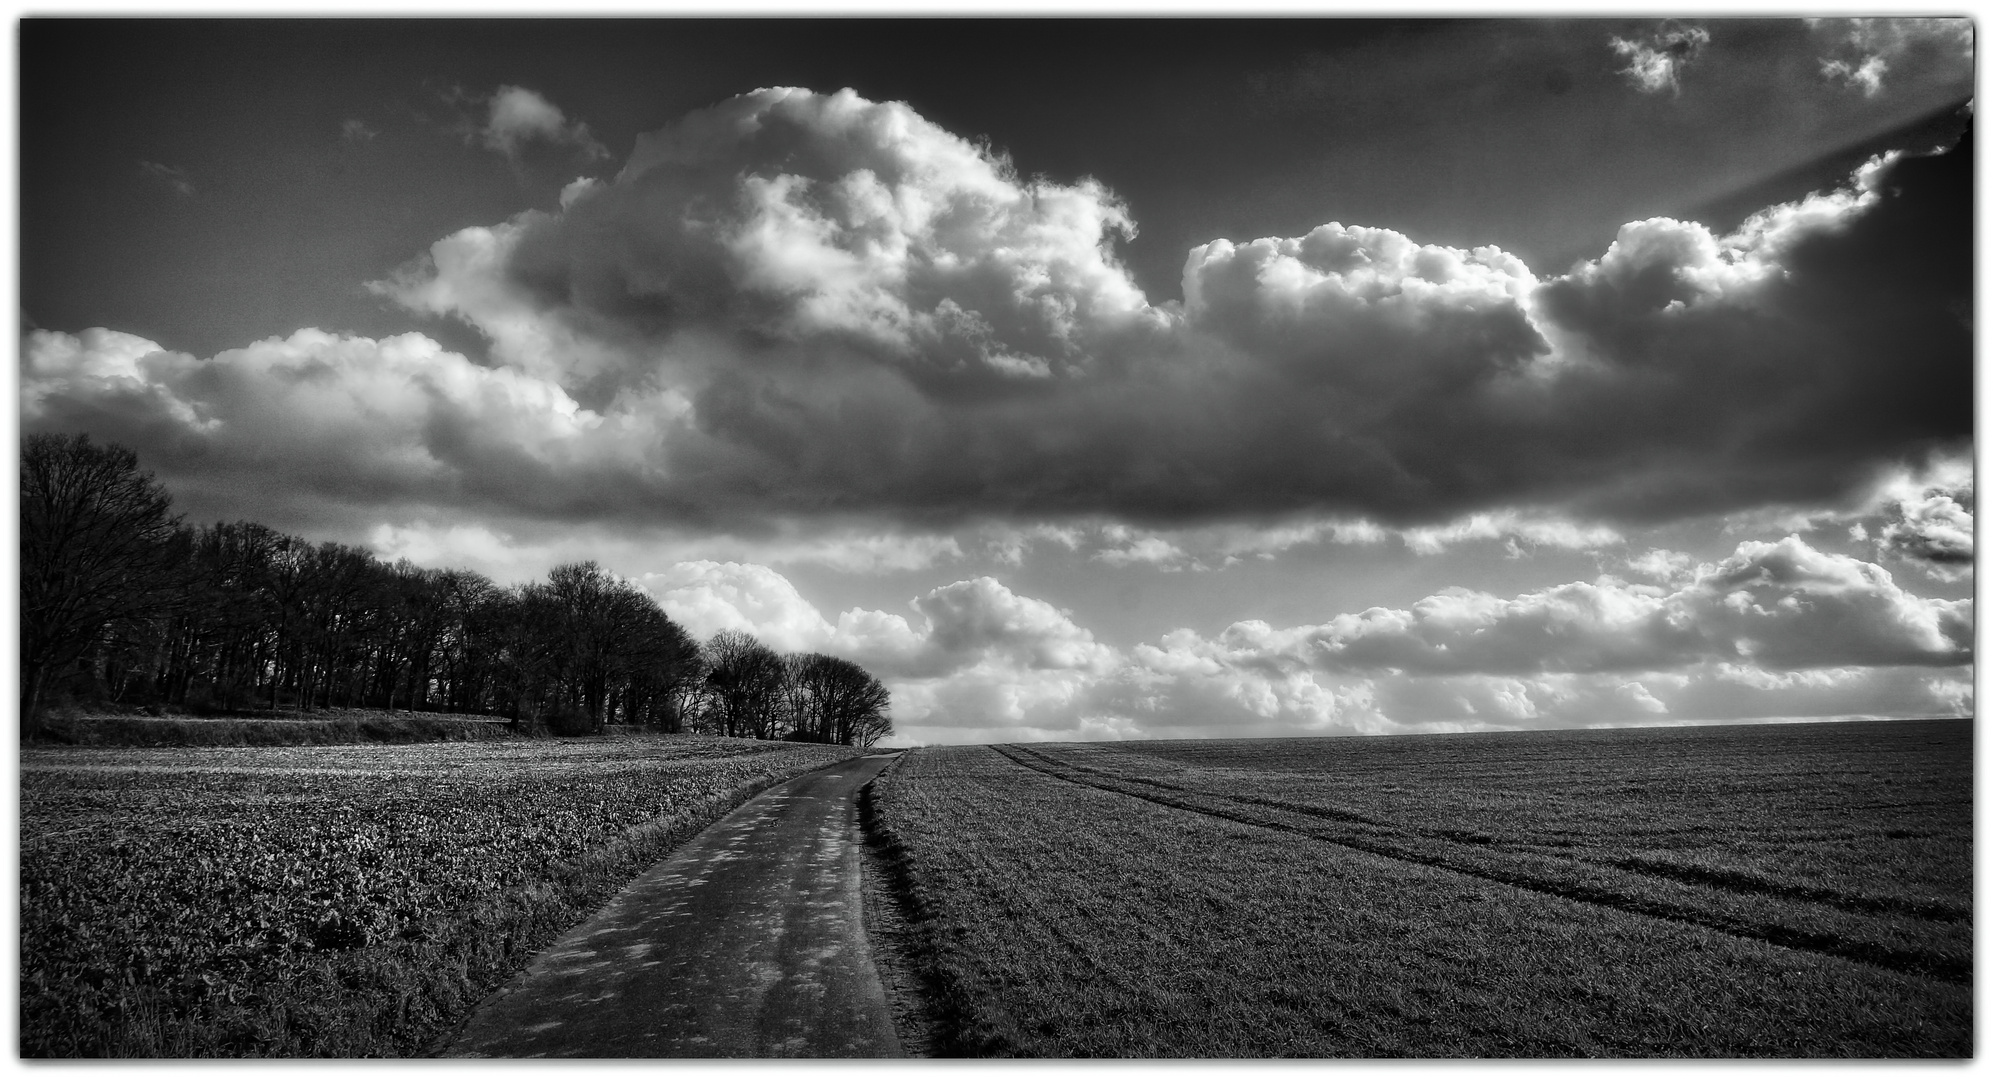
[20,18,1969,355]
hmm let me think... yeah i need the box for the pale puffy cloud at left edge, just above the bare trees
[22,329,670,534]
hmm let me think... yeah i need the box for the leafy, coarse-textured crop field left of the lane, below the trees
[20,735,855,1056]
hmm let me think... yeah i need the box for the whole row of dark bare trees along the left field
[20,434,891,745]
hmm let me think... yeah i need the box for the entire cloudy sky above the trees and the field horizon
[18,18,1975,745]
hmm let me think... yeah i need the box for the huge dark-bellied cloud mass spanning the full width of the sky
[24,90,1971,538]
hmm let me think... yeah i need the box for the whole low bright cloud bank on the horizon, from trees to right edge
[644,536,1973,741]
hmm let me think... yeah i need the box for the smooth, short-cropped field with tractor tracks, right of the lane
[871,721,1973,1056]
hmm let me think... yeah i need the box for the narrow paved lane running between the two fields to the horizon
[448,755,901,1058]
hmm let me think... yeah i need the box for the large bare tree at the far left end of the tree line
[20,434,185,737]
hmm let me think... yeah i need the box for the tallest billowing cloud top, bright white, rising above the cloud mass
[385,90,1146,391]
